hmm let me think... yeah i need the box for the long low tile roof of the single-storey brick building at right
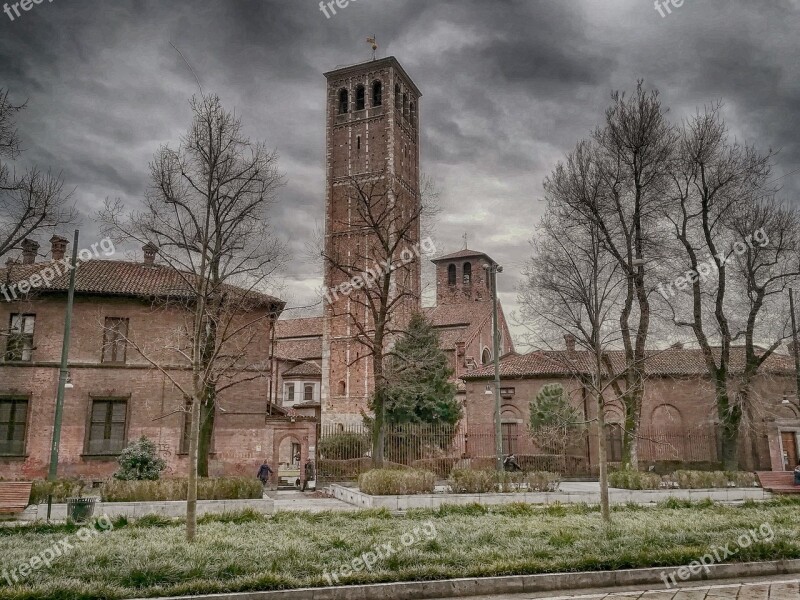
[463,346,794,379]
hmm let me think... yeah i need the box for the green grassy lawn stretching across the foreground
[0,500,800,600]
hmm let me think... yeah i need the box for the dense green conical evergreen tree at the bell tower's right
[386,313,462,425]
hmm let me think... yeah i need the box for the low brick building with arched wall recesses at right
[463,344,800,470]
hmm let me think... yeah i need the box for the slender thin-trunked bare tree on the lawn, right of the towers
[519,142,626,520]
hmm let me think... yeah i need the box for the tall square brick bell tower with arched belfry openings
[321,57,421,426]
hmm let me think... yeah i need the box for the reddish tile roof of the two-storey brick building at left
[0,260,284,309]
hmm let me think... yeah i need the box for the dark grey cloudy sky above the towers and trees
[0,0,800,346]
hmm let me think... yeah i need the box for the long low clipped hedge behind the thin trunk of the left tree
[102,477,263,502]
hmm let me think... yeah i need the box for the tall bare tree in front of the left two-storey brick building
[102,96,283,541]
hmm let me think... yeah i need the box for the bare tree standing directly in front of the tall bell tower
[322,173,436,466]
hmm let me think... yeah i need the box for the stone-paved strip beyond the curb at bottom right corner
[444,575,800,600]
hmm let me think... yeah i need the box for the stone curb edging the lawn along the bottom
[131,559,800,600]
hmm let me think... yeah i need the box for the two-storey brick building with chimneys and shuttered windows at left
[0,237,316,478]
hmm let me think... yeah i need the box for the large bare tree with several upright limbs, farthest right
[659,104,800,469]
